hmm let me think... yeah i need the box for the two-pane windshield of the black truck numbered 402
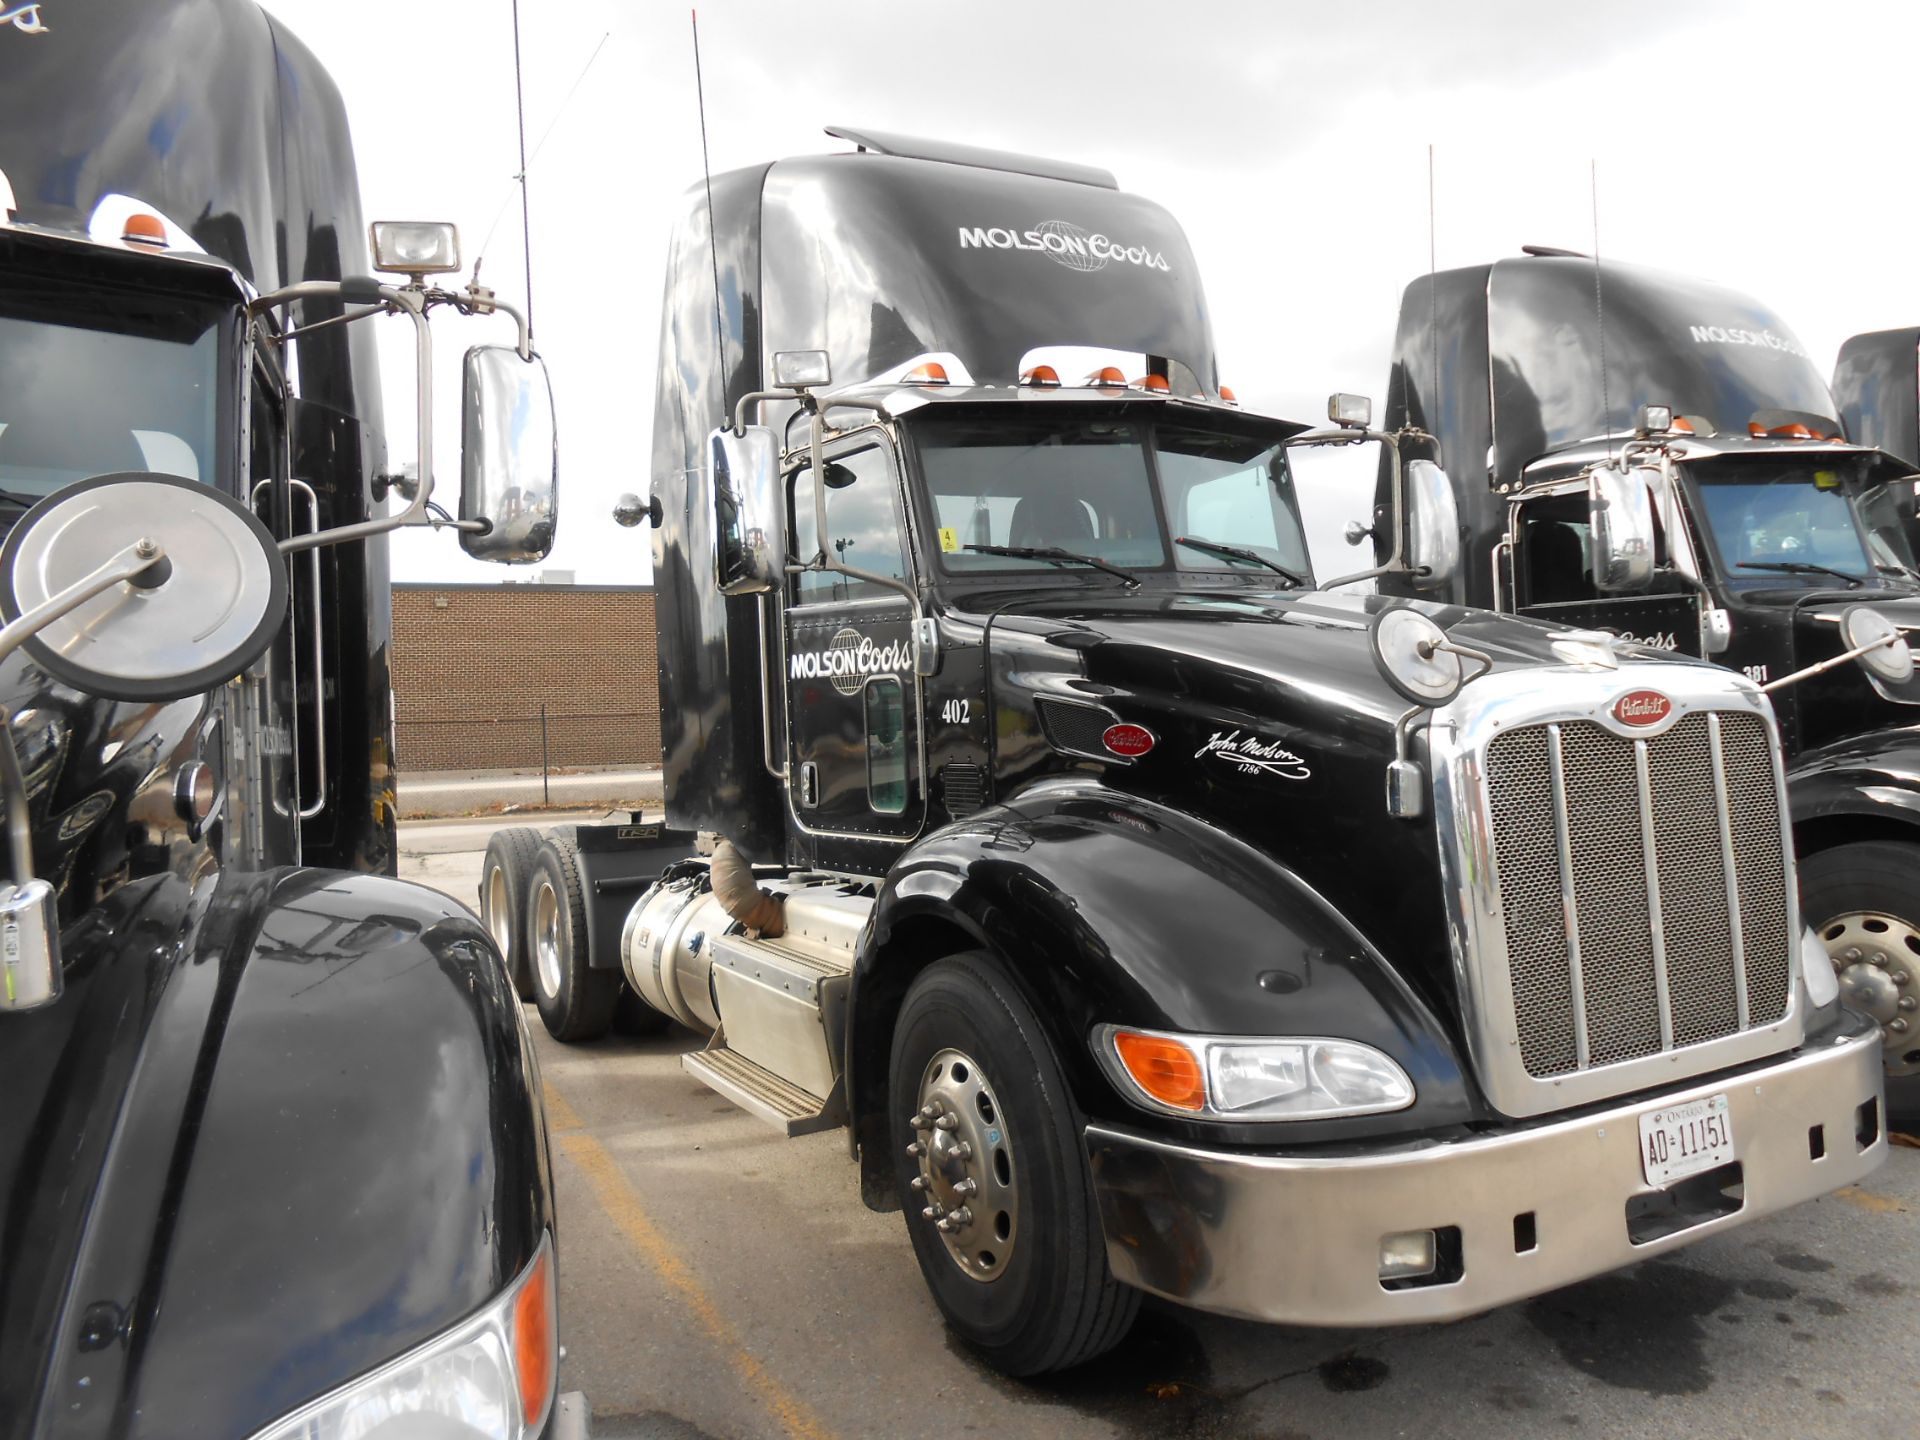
[916,417,1308,582]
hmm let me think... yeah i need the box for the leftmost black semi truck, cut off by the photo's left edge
[0,0,586,1440]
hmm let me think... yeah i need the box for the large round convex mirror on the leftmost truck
[0,472,286,701]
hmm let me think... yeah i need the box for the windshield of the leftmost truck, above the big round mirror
[0,292,221,503]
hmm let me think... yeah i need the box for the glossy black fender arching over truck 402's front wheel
[847,780,1488,1204]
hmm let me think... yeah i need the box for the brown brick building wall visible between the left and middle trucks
[394,584,660,772]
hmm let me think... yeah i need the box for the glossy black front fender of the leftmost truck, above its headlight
[13,870,553,1436]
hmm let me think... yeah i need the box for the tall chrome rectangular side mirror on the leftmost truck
[461,346,561,564]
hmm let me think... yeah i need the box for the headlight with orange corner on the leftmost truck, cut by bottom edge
[253,1236,559,1440]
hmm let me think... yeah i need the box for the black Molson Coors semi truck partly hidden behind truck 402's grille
[1374,252,1920,1114]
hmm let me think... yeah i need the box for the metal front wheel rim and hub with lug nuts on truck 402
[906,1050,1020,1281]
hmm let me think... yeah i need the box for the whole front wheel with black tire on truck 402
[887,952,1140,1375]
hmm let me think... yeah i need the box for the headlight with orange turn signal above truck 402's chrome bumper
[1094,1025,1413,1121]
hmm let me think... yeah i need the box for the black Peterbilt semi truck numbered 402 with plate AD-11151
[501,131,1885,1375]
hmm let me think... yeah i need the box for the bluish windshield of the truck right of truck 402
[1688,455,1912,589]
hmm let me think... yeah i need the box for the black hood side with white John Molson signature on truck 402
[991,588,1720,1008]
